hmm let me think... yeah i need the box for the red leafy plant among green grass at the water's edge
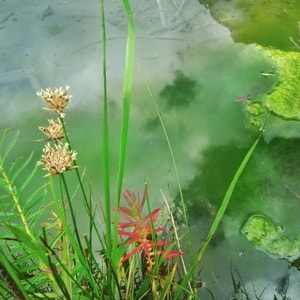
[118,190,182,275]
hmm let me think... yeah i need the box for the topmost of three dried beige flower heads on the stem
[36,86,72,118]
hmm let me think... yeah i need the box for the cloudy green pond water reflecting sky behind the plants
[0,0,300,299]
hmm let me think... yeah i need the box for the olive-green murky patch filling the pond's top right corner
[199,0,300,51]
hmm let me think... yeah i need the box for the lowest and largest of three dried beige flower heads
[37,143,77,177]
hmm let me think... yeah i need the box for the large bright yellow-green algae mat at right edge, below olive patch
[246,45,300,141]
